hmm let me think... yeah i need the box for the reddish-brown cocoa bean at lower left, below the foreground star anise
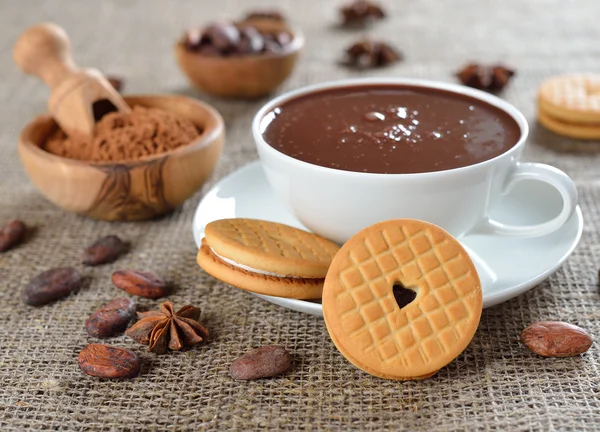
[77,344,141,378]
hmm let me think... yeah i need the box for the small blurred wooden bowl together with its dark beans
[175,18,304,98]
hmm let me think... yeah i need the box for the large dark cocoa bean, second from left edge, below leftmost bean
[21,267,82,306]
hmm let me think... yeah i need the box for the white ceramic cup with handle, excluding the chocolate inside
[252,78,577,243]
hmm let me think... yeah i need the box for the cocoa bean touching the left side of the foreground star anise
[85,297,135,338]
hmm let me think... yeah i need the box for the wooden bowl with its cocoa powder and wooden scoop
[14,24,224,220]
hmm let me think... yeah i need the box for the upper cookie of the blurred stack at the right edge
[538,73,600,127]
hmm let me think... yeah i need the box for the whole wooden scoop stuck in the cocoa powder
[13,23,130,136]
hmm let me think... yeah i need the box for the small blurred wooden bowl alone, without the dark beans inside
[175,19,304,99]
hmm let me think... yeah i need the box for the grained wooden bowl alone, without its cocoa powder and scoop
[18,95,224,221]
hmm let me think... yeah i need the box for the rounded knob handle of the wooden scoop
[13,23,79,89]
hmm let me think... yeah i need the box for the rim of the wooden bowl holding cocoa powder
[19,93,225,167]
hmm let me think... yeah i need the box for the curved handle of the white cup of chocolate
[474,163,577,237]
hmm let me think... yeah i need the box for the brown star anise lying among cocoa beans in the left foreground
[125,301,208,354]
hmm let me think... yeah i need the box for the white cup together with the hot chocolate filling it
[252,78,577,243]
